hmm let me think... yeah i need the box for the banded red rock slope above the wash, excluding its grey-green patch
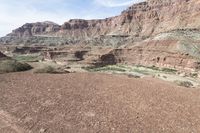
[98,40,200,71]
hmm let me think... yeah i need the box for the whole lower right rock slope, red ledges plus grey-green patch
[99,31,200,71]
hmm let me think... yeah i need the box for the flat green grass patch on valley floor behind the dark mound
[14,55,41,62]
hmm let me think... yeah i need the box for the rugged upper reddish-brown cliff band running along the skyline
[3,0,200,39]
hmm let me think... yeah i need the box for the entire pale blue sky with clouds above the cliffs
[0,0,143,36]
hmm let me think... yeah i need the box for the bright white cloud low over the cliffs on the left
[0,0,73,37]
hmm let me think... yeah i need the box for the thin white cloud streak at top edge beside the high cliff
[95,0,144,7]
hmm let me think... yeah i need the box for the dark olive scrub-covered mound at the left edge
[0,59,32,73]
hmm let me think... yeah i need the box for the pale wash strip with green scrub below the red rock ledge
[83,65,198,87]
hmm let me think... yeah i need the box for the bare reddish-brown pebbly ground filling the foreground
[0,73,200,133]
